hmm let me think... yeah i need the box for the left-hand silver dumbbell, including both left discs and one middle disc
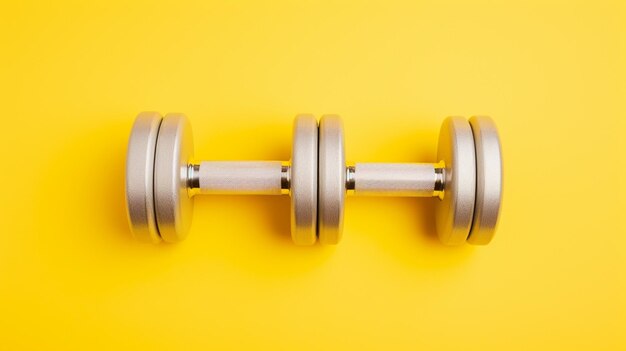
[126,112,318,245]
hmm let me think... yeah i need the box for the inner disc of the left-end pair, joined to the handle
[154,113,193,242]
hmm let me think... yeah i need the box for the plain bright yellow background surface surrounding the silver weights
[0,1,626,350]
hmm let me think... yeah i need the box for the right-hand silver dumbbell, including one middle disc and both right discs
[318,115,502,245]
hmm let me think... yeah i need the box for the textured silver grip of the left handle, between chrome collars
[198,161,282,195]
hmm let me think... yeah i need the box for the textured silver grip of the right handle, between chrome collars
[352,163,439,197]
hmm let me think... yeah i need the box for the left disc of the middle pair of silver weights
[290,115,318,245]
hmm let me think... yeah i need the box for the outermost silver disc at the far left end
[126,112,163,243]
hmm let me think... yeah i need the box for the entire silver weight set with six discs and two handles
[126,112,502,245]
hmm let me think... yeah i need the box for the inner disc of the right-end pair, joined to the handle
[435,117,476,245]
